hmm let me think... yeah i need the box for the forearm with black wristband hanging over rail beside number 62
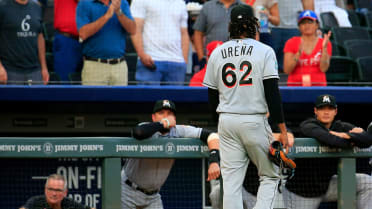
[200,129,220,181]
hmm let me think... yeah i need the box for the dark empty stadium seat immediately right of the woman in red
[326,56,357,86]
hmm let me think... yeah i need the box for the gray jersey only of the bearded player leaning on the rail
[123,125,202,191]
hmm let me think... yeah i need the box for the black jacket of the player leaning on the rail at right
[286,118,372,197]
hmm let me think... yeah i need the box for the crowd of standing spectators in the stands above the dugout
[0,0,372,86]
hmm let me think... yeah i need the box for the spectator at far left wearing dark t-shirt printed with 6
[0,0,49,84]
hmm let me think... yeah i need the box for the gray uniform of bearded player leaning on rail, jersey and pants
[121,125,202,209]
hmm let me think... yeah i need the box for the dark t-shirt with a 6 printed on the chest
[0,0,42,72]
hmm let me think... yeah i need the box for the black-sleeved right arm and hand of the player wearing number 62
[263,78,288,148]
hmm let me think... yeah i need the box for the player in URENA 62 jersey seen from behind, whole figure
[203,5,288,209]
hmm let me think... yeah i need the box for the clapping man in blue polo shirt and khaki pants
[76,0,136,86]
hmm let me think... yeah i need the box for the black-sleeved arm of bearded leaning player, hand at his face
[132,118,175,140]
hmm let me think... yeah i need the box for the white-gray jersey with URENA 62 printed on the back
[203,39,279,115]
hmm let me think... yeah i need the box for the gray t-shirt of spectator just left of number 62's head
[193,0,241,46]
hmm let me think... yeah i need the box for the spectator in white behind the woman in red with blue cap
[309,0,351,27]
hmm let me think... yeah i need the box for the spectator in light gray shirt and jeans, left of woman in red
[271,0,313,71]
